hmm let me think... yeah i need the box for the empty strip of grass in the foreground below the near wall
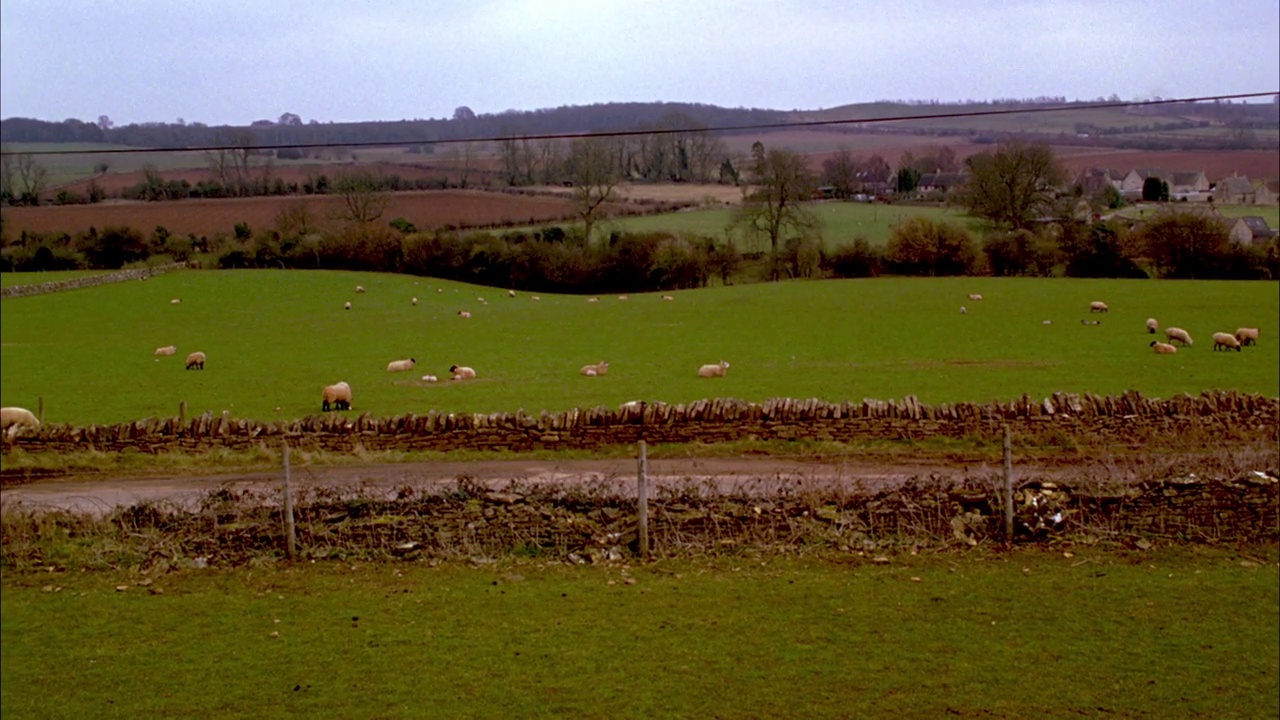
[0,547,1280,717]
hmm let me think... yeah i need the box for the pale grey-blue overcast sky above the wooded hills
[0,0,1280,124]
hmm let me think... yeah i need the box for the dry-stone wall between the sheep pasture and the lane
[4,391,1280,454]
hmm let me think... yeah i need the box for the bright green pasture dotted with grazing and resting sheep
[0,270,1280,424]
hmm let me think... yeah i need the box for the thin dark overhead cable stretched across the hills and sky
[0,91,1280,155]
